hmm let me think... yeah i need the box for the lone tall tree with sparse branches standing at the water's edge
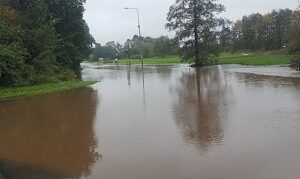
[166,0,225,66]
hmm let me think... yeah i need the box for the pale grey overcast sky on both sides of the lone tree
[84,0,297,44]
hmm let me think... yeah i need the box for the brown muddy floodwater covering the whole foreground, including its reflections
[0,64,300,179]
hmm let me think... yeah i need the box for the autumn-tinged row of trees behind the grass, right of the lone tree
[219,9,300,53]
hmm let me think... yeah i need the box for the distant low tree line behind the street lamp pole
[90,35,179,61]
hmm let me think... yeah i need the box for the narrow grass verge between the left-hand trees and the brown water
[0,80,97,100]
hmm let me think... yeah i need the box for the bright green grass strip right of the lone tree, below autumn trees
[219,53,293,66]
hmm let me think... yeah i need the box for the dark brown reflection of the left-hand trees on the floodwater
[0,89,99,179]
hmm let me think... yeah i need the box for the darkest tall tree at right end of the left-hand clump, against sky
[45,0,94,75]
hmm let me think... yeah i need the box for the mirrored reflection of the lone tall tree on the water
[174,68,229,149]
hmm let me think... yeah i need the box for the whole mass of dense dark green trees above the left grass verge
[0,0,94,86]
